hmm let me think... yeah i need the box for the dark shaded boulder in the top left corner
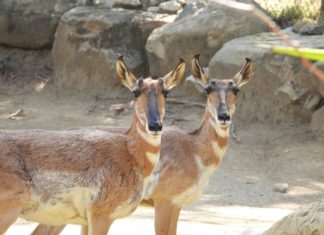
[0,0,90,49]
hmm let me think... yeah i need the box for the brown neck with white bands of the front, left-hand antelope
[127,115,161,178]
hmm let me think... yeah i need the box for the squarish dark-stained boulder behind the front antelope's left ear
[53,7,174,96]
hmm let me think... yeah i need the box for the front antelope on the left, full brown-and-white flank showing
[0,57,185,235]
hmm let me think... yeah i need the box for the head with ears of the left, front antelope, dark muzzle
[116,57,185,136]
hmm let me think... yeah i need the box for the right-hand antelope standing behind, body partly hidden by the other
[33,55,252,235]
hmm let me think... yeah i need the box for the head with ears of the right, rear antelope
[191,54,252,126]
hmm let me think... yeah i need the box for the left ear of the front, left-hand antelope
[116,56,136,91]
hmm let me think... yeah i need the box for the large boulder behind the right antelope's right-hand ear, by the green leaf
[209,33,324,123]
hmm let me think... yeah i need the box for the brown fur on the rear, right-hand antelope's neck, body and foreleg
[30,104,227,235]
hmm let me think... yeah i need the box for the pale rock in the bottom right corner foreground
[263,201,324,235]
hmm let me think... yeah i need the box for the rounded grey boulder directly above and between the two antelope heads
[146,3,266,74]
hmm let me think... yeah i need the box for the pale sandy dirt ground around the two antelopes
[0,48,324,235]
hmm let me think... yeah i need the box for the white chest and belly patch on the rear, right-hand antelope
[172,157,216,207]
